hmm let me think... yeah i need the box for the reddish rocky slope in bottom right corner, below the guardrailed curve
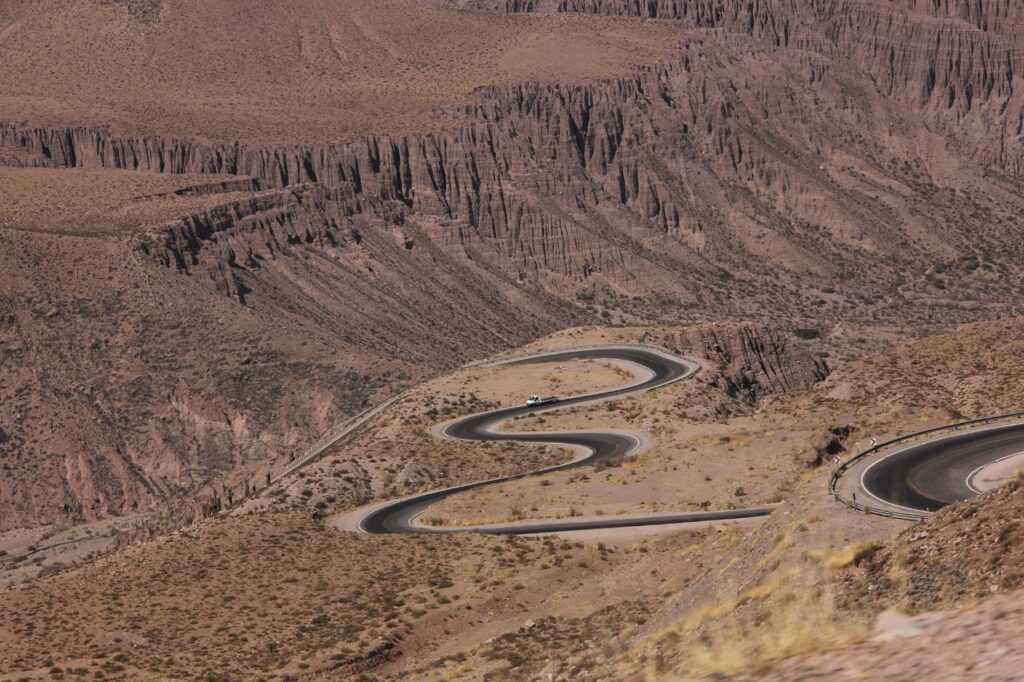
[739,458,1024,680]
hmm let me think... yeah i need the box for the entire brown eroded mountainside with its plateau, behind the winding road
[0,0,1024,614]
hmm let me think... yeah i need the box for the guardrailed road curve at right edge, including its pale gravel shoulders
[837,420,1024,516]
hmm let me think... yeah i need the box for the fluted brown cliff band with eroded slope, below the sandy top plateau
[0,0,1024,319]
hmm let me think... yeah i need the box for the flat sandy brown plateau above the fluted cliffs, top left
[0,0,680,144]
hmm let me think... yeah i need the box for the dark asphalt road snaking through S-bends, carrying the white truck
[356,346,772,535]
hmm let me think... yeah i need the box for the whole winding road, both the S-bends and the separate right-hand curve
[355,346,1024,535]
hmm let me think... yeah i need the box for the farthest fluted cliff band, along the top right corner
[435,0,1024,174]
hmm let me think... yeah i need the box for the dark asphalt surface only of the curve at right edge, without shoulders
[860,424,1024,512]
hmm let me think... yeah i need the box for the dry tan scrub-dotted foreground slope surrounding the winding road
[6,321,1024,680]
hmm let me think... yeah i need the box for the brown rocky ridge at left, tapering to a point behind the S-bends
[0,171,581,530]
